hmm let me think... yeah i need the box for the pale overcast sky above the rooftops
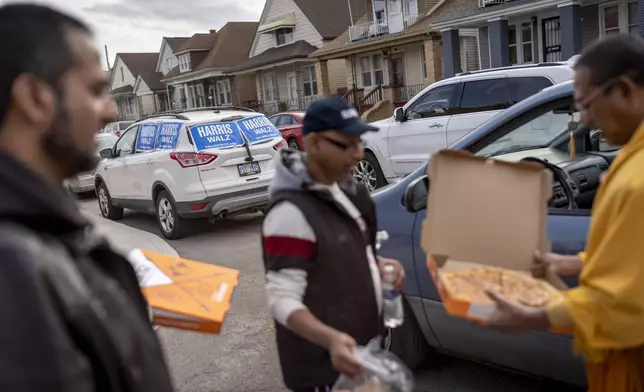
[0,0,265,68]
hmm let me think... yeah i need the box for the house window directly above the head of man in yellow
[599,0,639,36]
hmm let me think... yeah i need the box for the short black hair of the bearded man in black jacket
[0,4,91,124]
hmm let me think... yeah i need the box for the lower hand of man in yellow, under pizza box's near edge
[480,292,549,332]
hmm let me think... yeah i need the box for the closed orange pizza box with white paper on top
[128,249,239,334]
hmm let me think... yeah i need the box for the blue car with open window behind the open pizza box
[373,82,619,386]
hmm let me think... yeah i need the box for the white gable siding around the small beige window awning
[250,0,322,57]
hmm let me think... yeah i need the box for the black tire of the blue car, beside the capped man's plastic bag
[385,299,430,370]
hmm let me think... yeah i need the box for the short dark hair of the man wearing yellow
[575,34,644,86]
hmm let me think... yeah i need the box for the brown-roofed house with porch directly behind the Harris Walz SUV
[162,22,257,109]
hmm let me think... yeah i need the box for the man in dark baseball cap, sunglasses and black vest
[262,97,405,392]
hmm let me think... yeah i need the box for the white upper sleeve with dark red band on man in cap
[262,201,316,271]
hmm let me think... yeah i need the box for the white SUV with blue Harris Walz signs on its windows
[95,107,286,239]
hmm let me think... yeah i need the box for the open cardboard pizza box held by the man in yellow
[421,150,567,334]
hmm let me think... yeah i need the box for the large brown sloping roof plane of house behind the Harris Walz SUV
[195,22,258,71]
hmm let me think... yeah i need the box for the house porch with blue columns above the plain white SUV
[434,0,644,77]
